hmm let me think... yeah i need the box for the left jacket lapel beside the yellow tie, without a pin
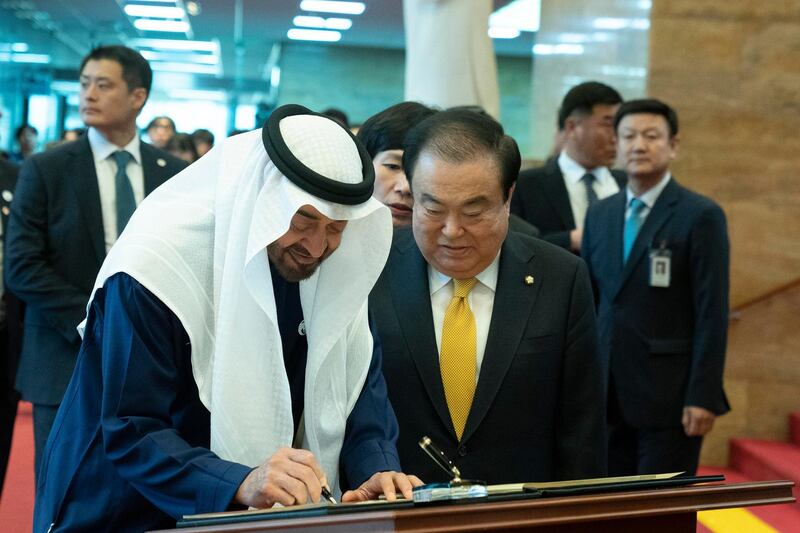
[390,237,456,439]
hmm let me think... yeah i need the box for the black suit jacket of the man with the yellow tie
[370,228,606,483]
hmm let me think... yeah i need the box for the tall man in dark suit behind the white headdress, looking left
[5,46,185,469]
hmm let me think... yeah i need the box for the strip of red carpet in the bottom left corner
[0,402,36,533]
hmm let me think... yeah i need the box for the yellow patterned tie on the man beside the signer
[439,278,478,440]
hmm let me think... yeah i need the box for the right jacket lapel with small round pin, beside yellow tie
[462,233,536,440]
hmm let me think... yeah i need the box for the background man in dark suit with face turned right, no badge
[511,81,625,253]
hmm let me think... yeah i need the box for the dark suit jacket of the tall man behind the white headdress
[5,135,186,405]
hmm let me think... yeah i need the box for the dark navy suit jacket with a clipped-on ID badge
[581,178,729,428]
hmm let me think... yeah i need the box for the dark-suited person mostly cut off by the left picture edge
[0,154,20,494]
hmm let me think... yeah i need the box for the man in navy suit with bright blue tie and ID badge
[582,96,729,475]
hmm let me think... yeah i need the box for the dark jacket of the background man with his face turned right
[511,157,627,250]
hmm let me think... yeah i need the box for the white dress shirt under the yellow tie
[428,252,500,381]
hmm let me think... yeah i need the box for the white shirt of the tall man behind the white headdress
[88,128,144,253]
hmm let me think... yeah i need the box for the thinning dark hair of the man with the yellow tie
[403,109,521,200]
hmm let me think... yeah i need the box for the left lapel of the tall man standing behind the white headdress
[69,135,106,263]
